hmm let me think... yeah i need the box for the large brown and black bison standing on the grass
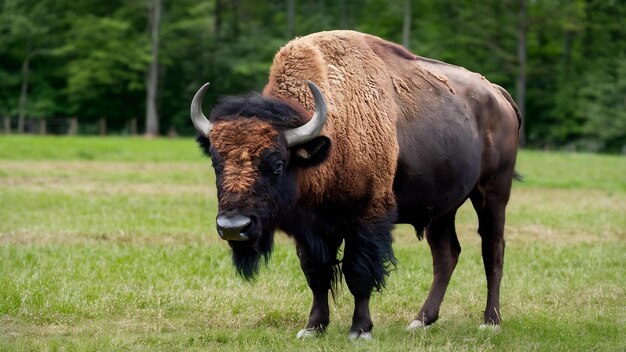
[191,31,521,339]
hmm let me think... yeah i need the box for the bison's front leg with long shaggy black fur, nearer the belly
[342,215,396,339]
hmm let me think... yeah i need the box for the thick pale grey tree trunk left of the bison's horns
[146,0,161,136]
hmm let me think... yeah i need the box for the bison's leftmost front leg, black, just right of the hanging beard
[297,238,340,338]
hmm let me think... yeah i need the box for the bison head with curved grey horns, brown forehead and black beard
[191,82,330,279]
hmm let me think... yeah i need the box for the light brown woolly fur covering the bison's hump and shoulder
[263,31,398,217]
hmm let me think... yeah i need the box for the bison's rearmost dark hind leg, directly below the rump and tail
[471,176,512,325]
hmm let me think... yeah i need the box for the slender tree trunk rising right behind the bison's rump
[515,0,528,146]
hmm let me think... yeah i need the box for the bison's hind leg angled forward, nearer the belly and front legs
[408,210,461,330]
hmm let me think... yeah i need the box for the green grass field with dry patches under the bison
[0,136,626,351]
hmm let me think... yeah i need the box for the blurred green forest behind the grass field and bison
[0,0,626,153]
